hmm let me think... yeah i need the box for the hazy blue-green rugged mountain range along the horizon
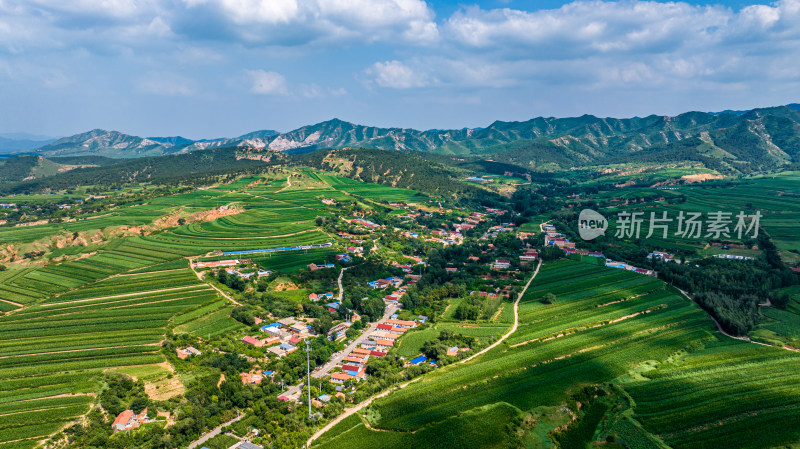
[0,104,800,173]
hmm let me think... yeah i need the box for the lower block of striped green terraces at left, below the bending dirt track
[0,268,217,449]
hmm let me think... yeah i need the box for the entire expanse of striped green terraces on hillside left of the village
[0,171,390,449]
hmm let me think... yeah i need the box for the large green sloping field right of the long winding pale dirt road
[315,261,800,448]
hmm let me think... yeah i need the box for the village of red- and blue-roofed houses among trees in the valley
[94,197,708,449]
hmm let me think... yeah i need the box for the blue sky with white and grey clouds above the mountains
[0,0,800,138]
